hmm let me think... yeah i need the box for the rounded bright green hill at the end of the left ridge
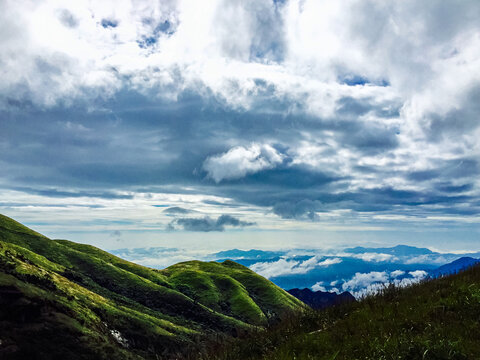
[162,260,305,326]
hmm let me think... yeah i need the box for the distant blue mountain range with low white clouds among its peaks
[212,245,480,296]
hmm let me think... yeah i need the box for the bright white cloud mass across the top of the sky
[1,0,480,126]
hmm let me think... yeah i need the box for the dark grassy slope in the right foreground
[204,265,480,360]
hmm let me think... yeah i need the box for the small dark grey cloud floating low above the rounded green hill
[168,215,256,232]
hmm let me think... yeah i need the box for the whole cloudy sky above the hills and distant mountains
[0,0,480,254]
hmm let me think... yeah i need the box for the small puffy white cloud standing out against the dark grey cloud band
[203,144,283,183]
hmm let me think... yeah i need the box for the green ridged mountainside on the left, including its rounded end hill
[0,215,305,359]
